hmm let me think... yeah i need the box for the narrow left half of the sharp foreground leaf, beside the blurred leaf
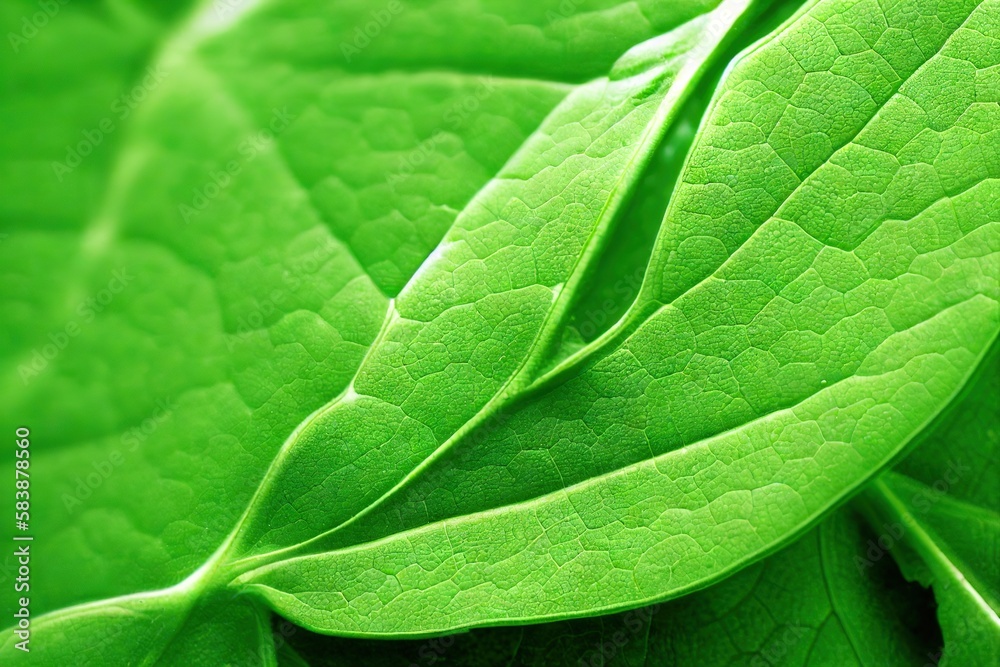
[233,2,747,555]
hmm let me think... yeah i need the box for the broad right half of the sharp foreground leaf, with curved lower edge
[239,2,1000,636]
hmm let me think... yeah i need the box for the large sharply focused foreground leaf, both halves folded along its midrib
[0,0,1000,664]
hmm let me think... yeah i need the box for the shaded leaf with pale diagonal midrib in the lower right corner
[862,352,1000,666]
